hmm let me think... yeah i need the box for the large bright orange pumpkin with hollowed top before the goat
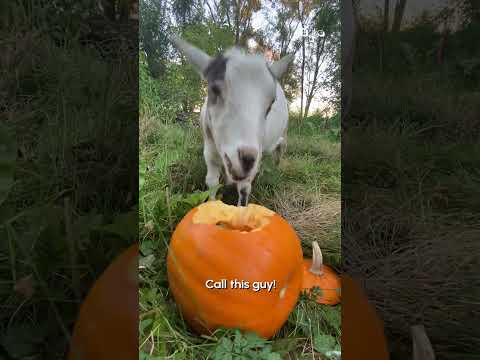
[167,201,303,338]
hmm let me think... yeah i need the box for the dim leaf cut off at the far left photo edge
[0,124,17,204]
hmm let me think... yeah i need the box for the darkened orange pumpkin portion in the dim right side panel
[341,274,389,360]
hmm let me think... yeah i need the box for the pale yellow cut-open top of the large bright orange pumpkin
[193,200,275,232]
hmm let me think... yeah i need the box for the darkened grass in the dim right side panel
[342,63,480,360]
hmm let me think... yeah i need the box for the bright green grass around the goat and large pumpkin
[140,117,341,359]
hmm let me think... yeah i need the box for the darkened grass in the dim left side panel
[0,1,138,360]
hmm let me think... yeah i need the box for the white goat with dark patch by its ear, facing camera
[171,37,293,206]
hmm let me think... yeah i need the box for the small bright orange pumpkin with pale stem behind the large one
[302,241,341,305]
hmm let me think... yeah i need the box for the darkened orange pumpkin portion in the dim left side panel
[68,244,138,360]
